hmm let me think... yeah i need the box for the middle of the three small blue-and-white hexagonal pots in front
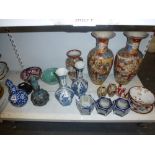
[95,97,113,116]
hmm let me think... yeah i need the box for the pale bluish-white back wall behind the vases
[0,32,152,72]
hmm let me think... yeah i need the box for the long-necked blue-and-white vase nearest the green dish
[55,68,74,106]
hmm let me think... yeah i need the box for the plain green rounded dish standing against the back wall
[41,68,58,85]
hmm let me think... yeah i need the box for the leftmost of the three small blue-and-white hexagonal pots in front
[76,95,95,115]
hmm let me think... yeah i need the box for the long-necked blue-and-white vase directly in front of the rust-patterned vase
[71,61,88,97]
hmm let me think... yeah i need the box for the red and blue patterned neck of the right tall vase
[126,38,141,52]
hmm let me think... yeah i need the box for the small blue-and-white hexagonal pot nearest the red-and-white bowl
[113,98,130,117]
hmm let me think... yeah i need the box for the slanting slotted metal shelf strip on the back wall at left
[7,29,24,69]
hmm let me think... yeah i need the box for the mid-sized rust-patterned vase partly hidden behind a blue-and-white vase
[66,49,83,80]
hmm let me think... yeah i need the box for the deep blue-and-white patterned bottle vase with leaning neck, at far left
[6,79,28,107]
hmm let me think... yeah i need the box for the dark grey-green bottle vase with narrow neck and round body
[30,76,49,106]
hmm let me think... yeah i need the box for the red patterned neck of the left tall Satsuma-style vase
[96,38,109,52]
